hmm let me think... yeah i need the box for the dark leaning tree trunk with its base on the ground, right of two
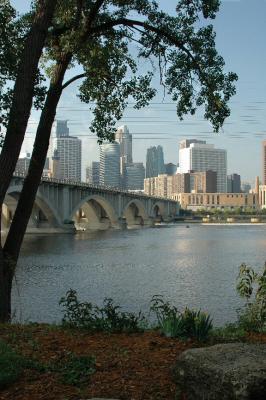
[0,54,71,321]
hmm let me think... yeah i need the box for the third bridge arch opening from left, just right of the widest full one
[122,199,149,227]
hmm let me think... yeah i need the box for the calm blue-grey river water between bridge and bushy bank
[12,224,266,325]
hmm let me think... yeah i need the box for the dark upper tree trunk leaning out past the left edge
[0,0,57,206]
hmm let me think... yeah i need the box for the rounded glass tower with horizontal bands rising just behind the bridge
[100,142,120,187]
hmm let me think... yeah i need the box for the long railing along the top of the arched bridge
[13,172,177,203]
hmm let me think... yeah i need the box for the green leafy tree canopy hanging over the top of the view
[0,0,237,141]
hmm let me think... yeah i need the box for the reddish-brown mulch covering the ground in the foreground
[0,325,266,400]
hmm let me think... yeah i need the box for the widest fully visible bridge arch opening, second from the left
[70,195,118,230]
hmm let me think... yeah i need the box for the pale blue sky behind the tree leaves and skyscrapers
[11,0,266,183]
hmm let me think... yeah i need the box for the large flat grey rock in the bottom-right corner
[174,343,266,400]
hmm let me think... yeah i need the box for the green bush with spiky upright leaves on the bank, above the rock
[150,295,212,341]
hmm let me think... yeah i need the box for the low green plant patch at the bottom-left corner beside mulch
[0,340,24,389]
